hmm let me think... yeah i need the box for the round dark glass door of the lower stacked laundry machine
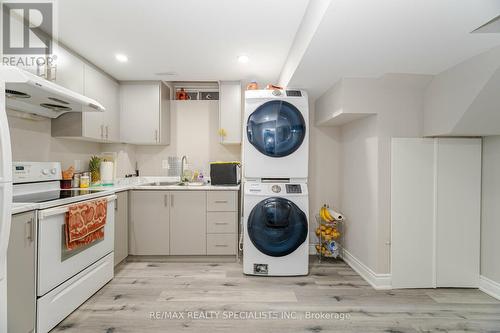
[247,198,308,257]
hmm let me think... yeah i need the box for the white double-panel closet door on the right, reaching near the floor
[391,138,481,288]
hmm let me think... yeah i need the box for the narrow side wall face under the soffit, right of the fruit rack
[338,116,378,270]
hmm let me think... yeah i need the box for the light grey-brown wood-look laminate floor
[53,261,500,333]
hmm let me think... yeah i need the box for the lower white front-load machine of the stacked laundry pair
[243,182,309,276]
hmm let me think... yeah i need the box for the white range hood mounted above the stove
[0,66,105,118]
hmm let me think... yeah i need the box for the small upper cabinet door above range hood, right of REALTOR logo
[54,45,84,94]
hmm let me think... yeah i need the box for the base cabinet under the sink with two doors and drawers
[129,190,238,256]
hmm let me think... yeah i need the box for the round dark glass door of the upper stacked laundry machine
[247,101,306,157]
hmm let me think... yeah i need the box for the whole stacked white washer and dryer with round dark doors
[243,90,309,276]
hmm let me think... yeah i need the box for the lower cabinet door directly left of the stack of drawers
[170,191,207,255]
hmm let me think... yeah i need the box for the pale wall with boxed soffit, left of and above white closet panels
[317,74,431,273]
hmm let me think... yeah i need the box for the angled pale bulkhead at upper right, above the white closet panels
[424,47,500,136]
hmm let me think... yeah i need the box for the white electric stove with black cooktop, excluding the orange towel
[12,162,116,333]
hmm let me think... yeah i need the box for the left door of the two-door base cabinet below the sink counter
[129,191,170,255]
